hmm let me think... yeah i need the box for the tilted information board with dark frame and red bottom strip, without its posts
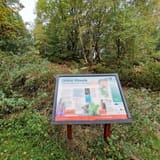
[52,74,131,124]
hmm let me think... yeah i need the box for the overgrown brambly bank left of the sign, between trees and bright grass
[0,54,72,116]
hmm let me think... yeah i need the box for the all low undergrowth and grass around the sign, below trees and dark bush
[0,55,160,160]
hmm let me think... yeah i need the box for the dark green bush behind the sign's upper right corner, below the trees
[93,61,160,91]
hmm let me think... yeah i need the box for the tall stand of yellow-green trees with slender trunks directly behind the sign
[34,0,159,64]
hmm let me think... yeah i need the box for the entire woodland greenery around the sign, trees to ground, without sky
[0,0,160,160]
